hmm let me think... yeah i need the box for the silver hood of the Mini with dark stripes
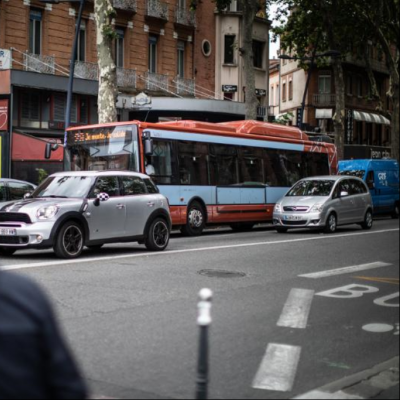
[0,199,84,219]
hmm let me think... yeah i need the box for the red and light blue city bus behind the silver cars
[65,121,338,236]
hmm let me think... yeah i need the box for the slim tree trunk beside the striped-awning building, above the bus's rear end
[333,58,346,161]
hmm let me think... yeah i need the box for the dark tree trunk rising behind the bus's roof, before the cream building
[242,0,259,120]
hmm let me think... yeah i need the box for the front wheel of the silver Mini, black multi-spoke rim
[54,222,85,259]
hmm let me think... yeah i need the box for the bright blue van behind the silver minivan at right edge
[339,160,400,219]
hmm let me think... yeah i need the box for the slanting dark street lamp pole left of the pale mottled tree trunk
[40,0,85,145]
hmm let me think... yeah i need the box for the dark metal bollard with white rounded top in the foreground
[196,289,213,400]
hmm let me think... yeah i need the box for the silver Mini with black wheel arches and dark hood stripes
[0,172,171,259]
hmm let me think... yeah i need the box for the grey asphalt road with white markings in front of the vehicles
[0,218,399,399]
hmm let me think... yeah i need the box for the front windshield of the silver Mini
[32,176,95,199]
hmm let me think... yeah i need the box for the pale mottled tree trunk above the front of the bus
[94,0,117,124]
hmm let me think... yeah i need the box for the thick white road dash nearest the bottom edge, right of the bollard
[253,343,301,392]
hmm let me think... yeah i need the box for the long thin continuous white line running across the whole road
[0,229,400,271]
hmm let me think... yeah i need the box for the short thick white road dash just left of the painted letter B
[278,289,315,329]
